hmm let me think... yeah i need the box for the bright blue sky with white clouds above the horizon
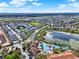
[0,0,79,13]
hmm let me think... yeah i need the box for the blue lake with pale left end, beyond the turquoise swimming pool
[44,31,79,41]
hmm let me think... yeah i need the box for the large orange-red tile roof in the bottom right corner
[47,52,79,59]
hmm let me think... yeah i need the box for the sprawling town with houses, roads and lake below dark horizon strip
[0,15,79,59]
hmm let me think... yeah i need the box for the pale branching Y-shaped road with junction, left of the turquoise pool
[7,26,45,59]
